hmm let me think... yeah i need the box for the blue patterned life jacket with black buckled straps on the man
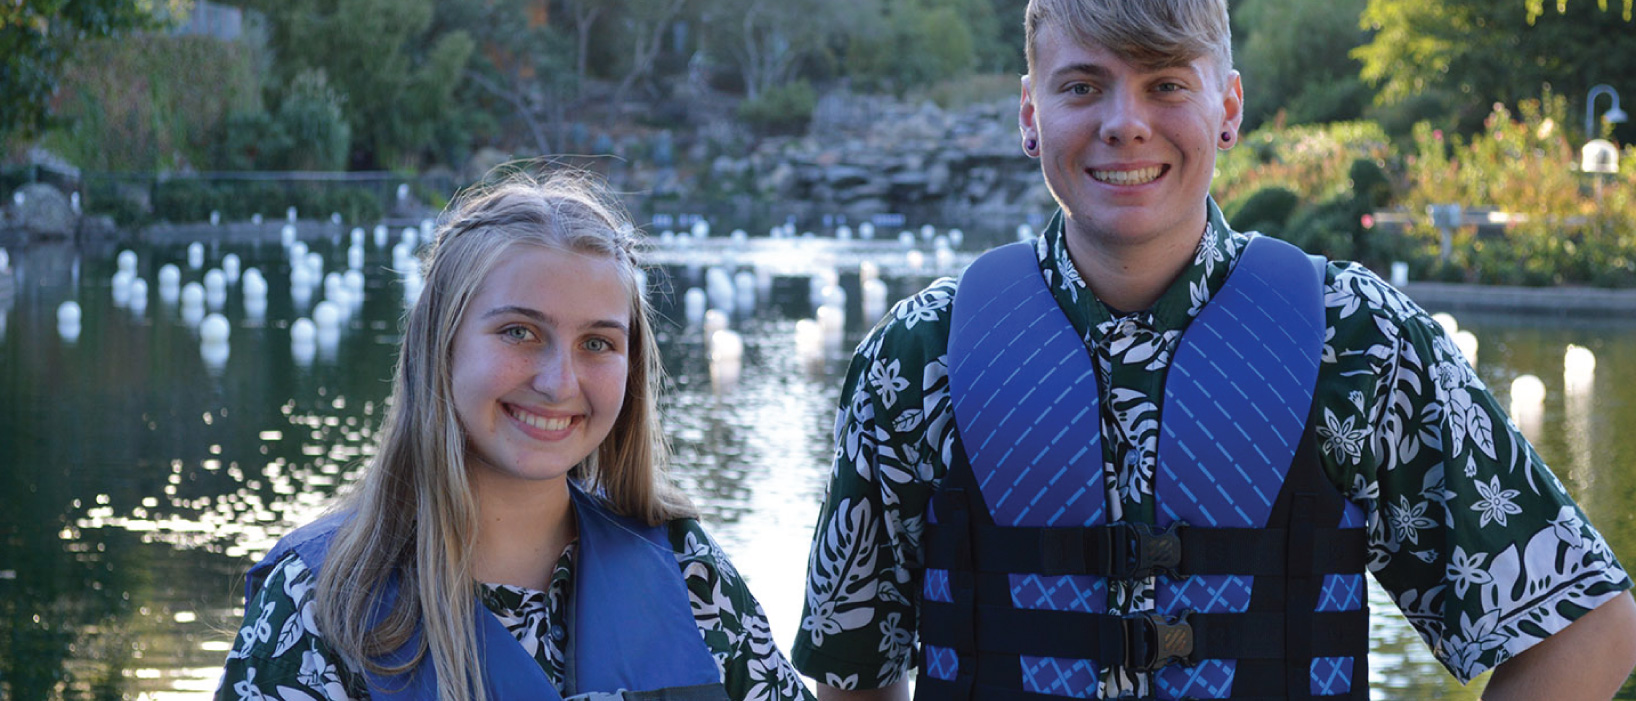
[916,236,1368,701]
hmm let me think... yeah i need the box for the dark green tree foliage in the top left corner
[0,0,169,144]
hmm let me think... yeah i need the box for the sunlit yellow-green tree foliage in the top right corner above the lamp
[1353,0,1636,133]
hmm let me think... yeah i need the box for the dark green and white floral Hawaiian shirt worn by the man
[792,203,1631,698]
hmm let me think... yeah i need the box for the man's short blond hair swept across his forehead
[1024,0,1232,80]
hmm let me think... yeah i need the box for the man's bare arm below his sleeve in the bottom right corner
[1485,593,1636,701]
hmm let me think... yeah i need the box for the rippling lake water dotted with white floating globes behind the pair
[0,224,1636,699]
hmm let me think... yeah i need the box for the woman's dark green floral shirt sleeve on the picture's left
[216,552,368,701]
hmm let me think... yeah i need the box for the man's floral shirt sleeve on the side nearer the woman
[793,280,954,690]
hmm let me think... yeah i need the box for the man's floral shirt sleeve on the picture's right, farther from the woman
[1317,269,1631,681]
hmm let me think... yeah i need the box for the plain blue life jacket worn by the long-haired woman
[244,482,728,701]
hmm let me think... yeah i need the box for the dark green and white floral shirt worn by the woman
[216,519,811,701]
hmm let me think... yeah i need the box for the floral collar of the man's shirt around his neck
[1036,198,1250,342]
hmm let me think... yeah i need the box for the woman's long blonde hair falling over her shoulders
[317,172,695,701]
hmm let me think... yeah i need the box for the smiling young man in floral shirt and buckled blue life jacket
[793,0,1636,701]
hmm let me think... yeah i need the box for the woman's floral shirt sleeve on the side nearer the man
[671,519,811,701]
